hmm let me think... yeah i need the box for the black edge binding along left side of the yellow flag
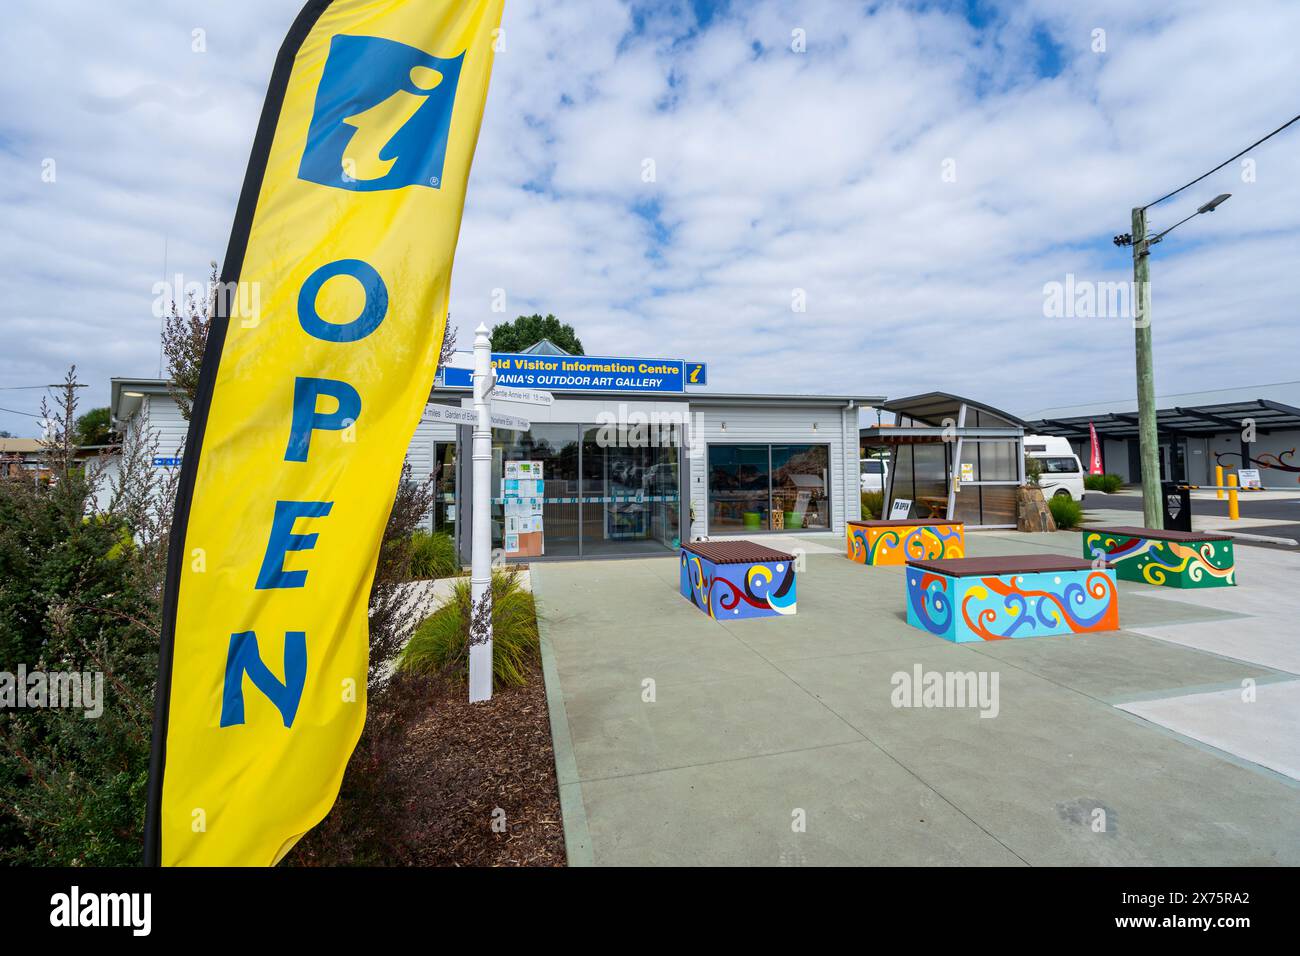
[144,0,334,866]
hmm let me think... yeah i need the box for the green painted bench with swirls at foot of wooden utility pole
[1080,525,1236,588]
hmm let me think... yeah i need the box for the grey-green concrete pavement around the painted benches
[532,532,1300,865]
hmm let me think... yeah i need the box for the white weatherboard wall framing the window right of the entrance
[690,402,862,536]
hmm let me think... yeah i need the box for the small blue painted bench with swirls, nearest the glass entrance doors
[681,541,794,620]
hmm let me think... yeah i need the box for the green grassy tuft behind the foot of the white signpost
[398,571,540,687]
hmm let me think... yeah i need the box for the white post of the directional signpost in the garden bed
[469,323,493,704]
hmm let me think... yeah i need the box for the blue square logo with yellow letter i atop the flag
[298,34,465,191]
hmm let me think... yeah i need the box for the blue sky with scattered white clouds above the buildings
[0,0,1300,434]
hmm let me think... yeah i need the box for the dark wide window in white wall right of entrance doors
[709,445,831,533]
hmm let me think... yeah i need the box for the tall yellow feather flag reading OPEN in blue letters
[146,0,503,866]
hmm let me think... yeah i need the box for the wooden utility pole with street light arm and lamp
[1114,193,1232,529]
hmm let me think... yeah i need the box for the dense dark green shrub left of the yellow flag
[0,455,163,866]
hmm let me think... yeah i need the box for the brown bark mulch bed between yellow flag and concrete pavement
[283,666,567,866]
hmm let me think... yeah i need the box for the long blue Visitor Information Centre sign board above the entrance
[442,352,706,392]
